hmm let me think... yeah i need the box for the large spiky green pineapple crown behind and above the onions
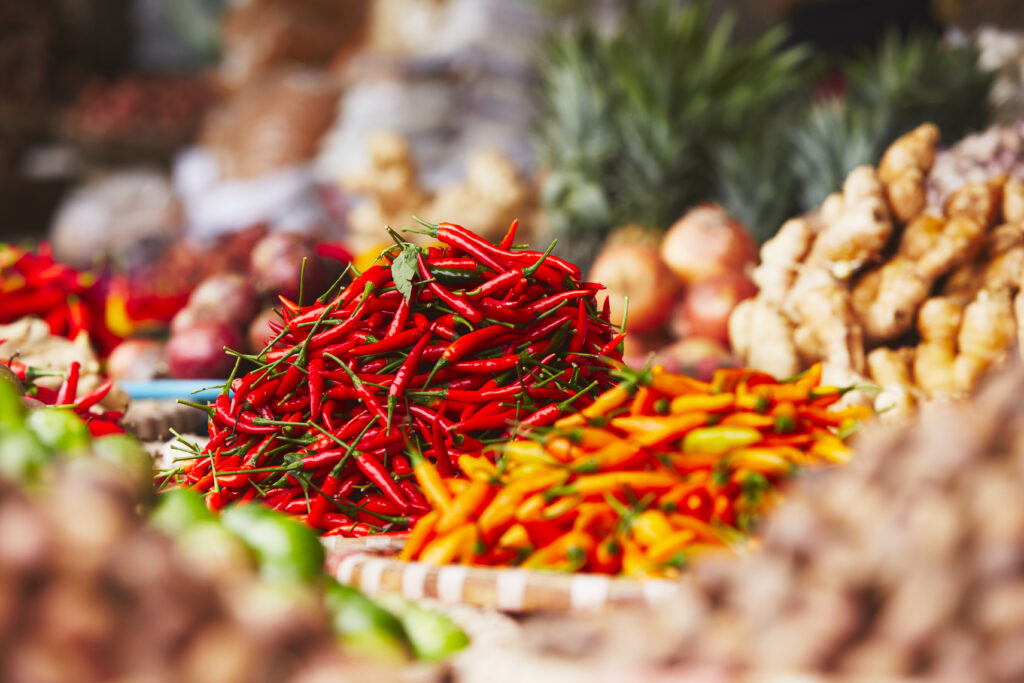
[537,0,806,265]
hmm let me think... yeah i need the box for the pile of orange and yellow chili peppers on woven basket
[401,366,870,577]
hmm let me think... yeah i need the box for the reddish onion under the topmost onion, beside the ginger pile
[672,270,758,345]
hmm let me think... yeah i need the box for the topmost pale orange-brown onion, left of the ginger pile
[662,204,758,284]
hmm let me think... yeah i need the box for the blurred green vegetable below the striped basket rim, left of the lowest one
[324,579,410,659]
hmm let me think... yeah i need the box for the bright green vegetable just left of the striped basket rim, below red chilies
[220,504,324,582]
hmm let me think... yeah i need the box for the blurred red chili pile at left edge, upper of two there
[0,243,121,355]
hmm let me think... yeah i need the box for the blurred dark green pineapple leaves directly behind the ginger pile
[716,28,992,229]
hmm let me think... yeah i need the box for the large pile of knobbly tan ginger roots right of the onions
[729,124,1024,418]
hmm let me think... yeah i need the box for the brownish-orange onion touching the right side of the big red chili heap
[590,244,679,332]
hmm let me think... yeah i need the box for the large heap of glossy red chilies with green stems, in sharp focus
[179,223,622,536]
